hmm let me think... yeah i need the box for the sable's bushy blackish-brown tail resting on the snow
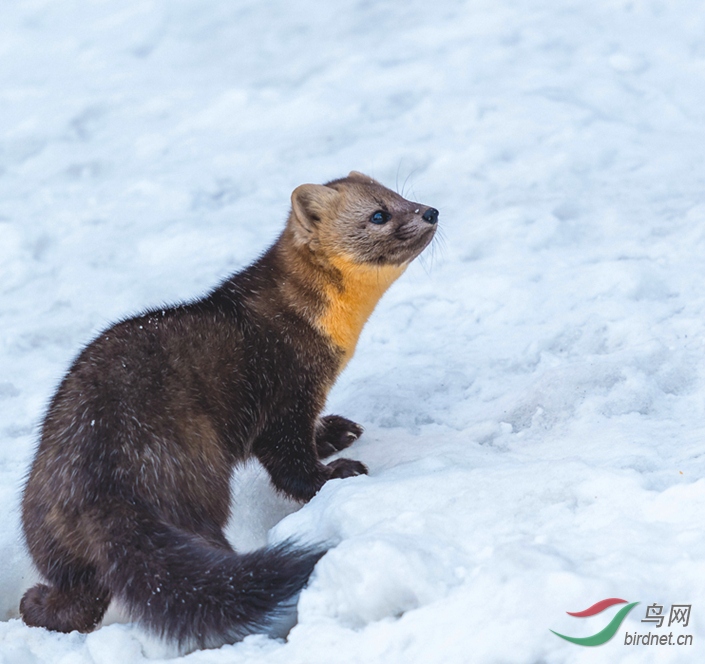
[109,524,324,648]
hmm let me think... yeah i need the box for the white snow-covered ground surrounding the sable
[0,0,705,664]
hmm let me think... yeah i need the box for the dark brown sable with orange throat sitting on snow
[20,172,438,648]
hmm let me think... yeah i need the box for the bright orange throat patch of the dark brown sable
[316,256,407,371]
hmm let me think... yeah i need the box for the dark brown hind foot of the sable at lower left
[20,574,110,632]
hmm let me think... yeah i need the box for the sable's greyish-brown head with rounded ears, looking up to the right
[289,171,438,266]
